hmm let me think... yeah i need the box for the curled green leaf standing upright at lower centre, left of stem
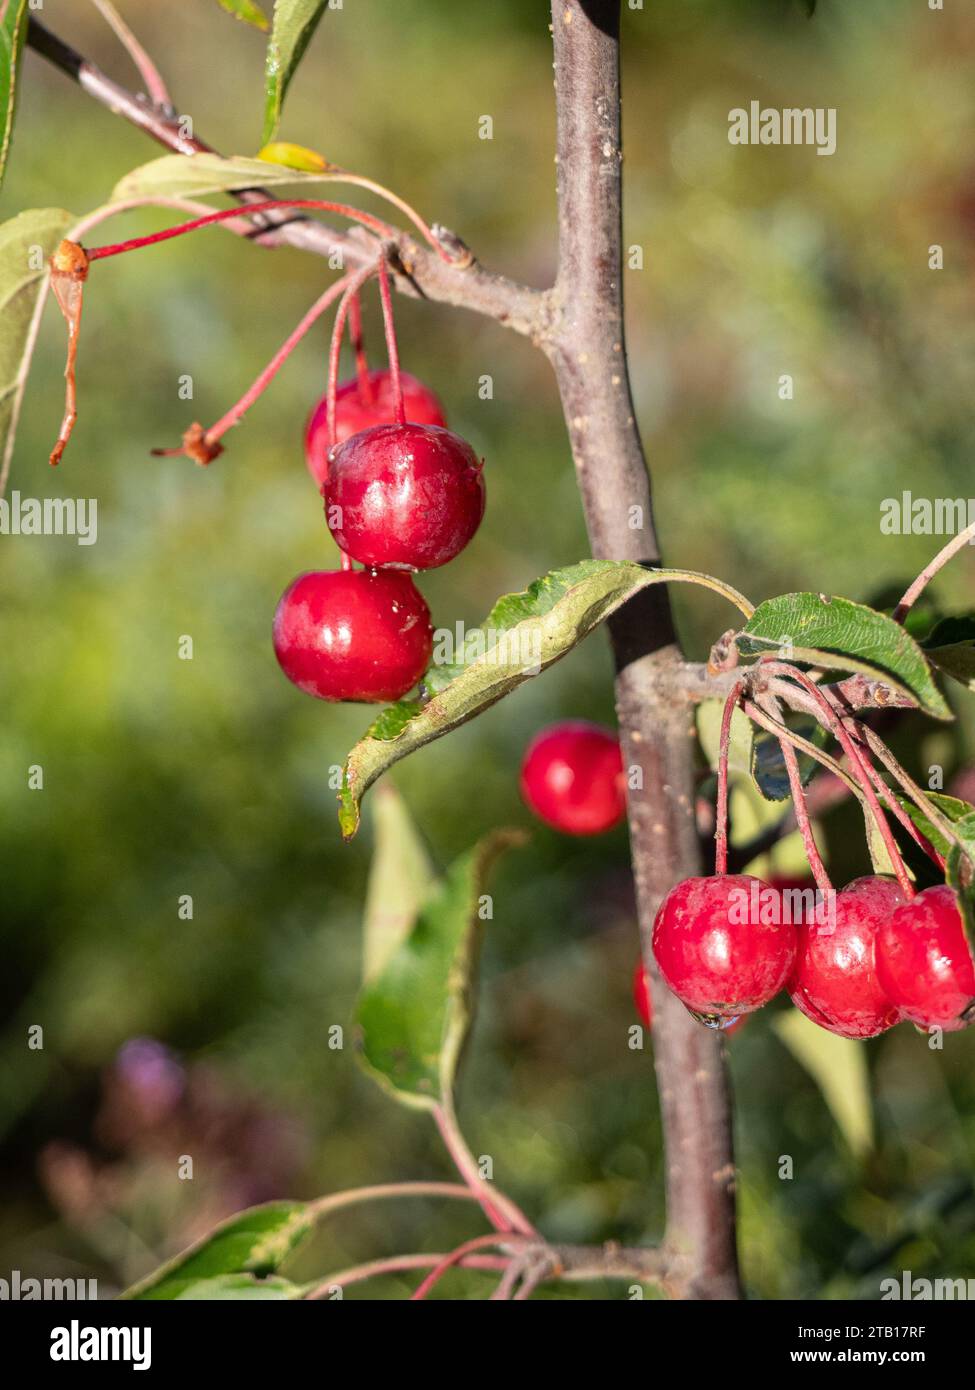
[356,830,524,1109]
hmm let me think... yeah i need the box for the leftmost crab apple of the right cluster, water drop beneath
[652,874,796,1023]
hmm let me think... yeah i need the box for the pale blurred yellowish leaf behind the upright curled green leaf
[362,784,434,984]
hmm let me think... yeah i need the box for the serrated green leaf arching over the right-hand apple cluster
[737,594,951,719]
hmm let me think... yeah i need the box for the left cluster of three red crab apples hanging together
[274,371,484,703]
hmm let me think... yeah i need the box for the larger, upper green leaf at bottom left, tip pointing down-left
[121,1201,314,1298]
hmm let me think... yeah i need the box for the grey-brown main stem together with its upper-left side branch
[28,0,740,1298]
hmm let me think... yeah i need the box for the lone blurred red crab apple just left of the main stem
[520,719,626,835]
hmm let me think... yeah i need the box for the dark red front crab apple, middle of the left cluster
[321,424,484,570]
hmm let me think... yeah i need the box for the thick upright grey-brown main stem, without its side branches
[548,0,740,1298]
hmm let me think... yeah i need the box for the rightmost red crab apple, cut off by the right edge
[876,883,975,1033]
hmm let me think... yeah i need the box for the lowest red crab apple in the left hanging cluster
[274,570,433,702]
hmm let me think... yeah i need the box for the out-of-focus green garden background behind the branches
[0,0,975,1298]
